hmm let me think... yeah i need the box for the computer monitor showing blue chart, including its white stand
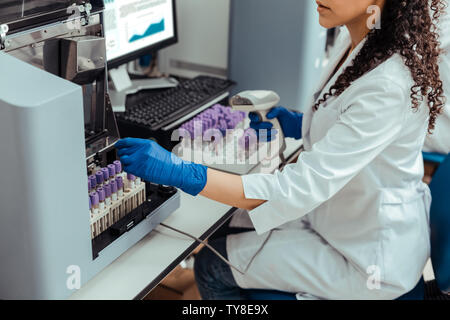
[104,0,178,112]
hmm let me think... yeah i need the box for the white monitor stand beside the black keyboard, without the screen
[109,65,178,112]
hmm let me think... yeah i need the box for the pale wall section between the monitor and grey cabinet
[159,0,230,78]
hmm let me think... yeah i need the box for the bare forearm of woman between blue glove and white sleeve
[200,169,266,210]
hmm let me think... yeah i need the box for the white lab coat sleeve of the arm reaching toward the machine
[242,77,412,234]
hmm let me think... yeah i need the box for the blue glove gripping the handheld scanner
[249,107,303,141]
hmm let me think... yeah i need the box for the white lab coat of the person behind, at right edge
[423,9,450,154]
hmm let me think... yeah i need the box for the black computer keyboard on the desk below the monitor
[116,76,235,131]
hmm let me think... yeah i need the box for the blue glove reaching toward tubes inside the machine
[116,138,207,196]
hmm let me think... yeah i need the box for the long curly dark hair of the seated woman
[313,0,446,133]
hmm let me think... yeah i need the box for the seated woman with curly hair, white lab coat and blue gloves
[117,0,443,299]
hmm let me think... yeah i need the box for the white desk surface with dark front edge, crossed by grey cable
[70,139,301,300]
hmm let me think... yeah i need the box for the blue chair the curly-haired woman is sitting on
[244,155,450,300]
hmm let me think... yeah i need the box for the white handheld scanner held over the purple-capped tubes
[230,90,286,153]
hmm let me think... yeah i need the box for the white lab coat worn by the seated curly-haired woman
[227,28,431,299]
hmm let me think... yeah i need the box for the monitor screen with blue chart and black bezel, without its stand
[104,0,177,69]
